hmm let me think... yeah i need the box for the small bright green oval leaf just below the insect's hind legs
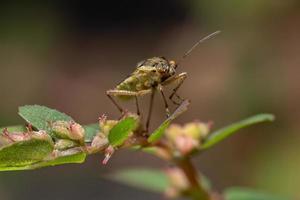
[108,117,138,147]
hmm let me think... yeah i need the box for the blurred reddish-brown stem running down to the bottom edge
[176,157,211,200]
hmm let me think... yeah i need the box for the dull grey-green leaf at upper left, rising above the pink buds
[19,105,73,133]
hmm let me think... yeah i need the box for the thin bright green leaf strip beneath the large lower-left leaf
[30,152,86,169]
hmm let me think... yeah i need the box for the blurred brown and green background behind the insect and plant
[0,0,300,200]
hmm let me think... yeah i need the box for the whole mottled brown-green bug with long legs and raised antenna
[106,31,220,132]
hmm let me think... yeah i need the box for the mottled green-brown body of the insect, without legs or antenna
[117,57,175,91]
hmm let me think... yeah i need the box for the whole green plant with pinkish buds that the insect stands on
[0,101,284,200]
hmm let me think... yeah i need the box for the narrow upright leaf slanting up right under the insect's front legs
[148,100,190,143]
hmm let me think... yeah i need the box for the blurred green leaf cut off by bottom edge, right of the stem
[224,187,291,200]
